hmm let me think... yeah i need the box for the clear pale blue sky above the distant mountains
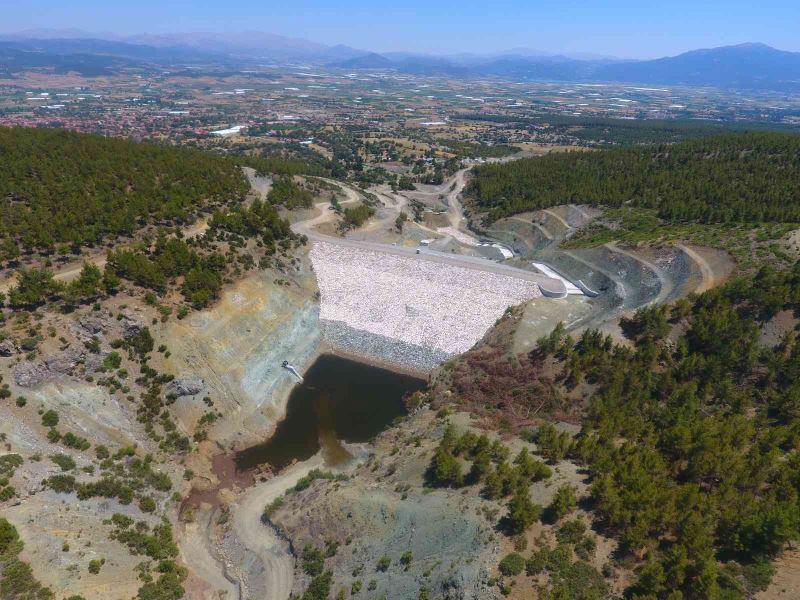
[6,0,800,58]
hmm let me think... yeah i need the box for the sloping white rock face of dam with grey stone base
[311,242,541,369]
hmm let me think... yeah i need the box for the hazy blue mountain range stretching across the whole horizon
[0,30,800,92]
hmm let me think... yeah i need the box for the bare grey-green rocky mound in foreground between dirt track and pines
[274,410,500,600]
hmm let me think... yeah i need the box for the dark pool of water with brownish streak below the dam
[236,354,425,470]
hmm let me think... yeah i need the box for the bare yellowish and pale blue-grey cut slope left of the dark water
[159,263,321,447]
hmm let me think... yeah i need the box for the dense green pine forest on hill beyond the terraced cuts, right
[470,133,800,223]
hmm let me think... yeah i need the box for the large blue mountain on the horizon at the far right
[594,44,800,91]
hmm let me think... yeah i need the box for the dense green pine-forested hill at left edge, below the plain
[0,127,248,250]
